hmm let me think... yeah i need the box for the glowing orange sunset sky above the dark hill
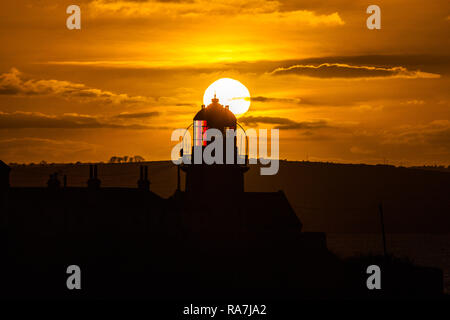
[0,0,450,165]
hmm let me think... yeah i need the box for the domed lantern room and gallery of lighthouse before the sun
[180,95,249,198]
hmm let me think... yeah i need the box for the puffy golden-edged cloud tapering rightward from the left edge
[0,68,149,104]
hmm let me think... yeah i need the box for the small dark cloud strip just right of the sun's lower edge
[238,116,328,130]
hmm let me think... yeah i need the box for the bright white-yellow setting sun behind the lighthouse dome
[203,78,250,115]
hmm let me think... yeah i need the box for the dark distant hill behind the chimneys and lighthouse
[11,161,450,233]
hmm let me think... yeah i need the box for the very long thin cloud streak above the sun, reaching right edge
[44,55,450,78]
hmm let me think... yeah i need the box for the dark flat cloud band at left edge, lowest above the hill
[0,111,160,130]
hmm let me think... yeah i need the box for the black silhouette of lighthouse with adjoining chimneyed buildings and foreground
[0,98,442,299]
